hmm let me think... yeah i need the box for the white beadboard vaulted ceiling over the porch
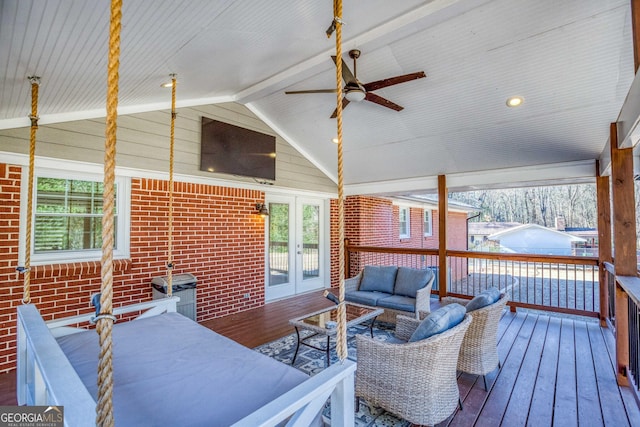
[0,0,634,194]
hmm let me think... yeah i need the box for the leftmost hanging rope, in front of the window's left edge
[17,76,40,304]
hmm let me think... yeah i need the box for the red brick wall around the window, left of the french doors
[0,164,265,372]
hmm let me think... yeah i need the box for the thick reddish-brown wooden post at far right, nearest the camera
[610,123,638,385]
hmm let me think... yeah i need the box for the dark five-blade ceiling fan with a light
[285,49,427,119]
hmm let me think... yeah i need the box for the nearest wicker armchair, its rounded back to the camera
[356,314,472,425]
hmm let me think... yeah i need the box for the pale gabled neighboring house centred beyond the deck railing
[488,224,586,255]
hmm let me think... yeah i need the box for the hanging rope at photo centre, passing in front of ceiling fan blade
[329,0,348,361]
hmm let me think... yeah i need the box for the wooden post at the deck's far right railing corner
[596,161,615,327]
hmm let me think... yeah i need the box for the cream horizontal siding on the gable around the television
[0,103,337,193]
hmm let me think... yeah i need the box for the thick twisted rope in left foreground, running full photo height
[96,0,122,427]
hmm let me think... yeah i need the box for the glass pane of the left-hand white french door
[269,203,289,286]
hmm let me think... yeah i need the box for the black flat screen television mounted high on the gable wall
[200,117,276,180]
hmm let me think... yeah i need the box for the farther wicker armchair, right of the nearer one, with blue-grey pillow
[442,293,509,390]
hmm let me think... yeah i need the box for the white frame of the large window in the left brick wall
[18,166,131,265]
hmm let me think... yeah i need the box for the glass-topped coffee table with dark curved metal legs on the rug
[289,302,384,366]
